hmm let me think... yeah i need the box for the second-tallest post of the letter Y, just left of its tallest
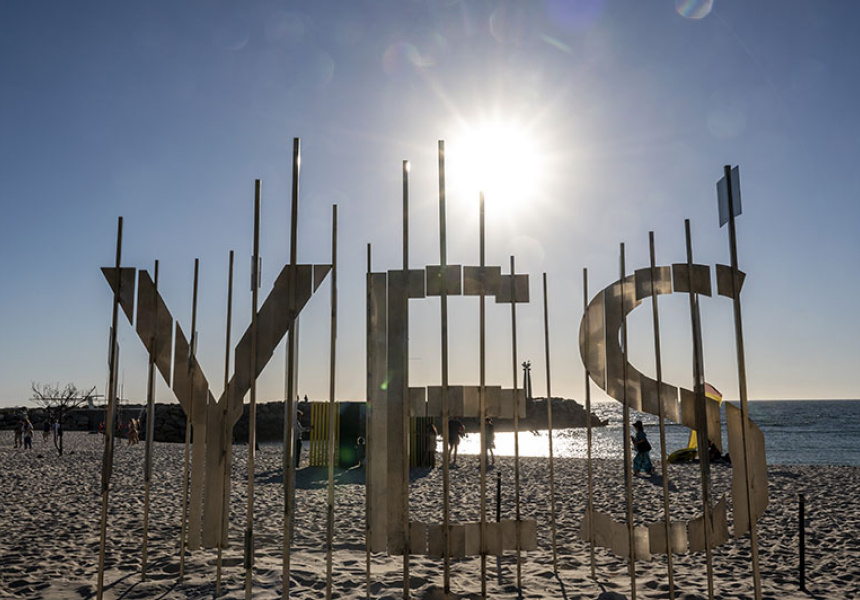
[245,179,262,600]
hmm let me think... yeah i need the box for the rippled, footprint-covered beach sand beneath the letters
[0,432,860,599]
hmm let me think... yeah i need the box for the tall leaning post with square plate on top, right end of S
[723,165,761,600]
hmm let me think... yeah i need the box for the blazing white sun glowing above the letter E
[446,120,542,213]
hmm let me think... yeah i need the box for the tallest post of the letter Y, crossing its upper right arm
[281,138,301,598]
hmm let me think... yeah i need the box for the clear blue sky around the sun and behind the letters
[0,0,860,405]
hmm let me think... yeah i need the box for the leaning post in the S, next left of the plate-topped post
[684,219,714,600]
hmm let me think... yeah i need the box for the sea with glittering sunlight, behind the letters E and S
[450,400,860,467]
